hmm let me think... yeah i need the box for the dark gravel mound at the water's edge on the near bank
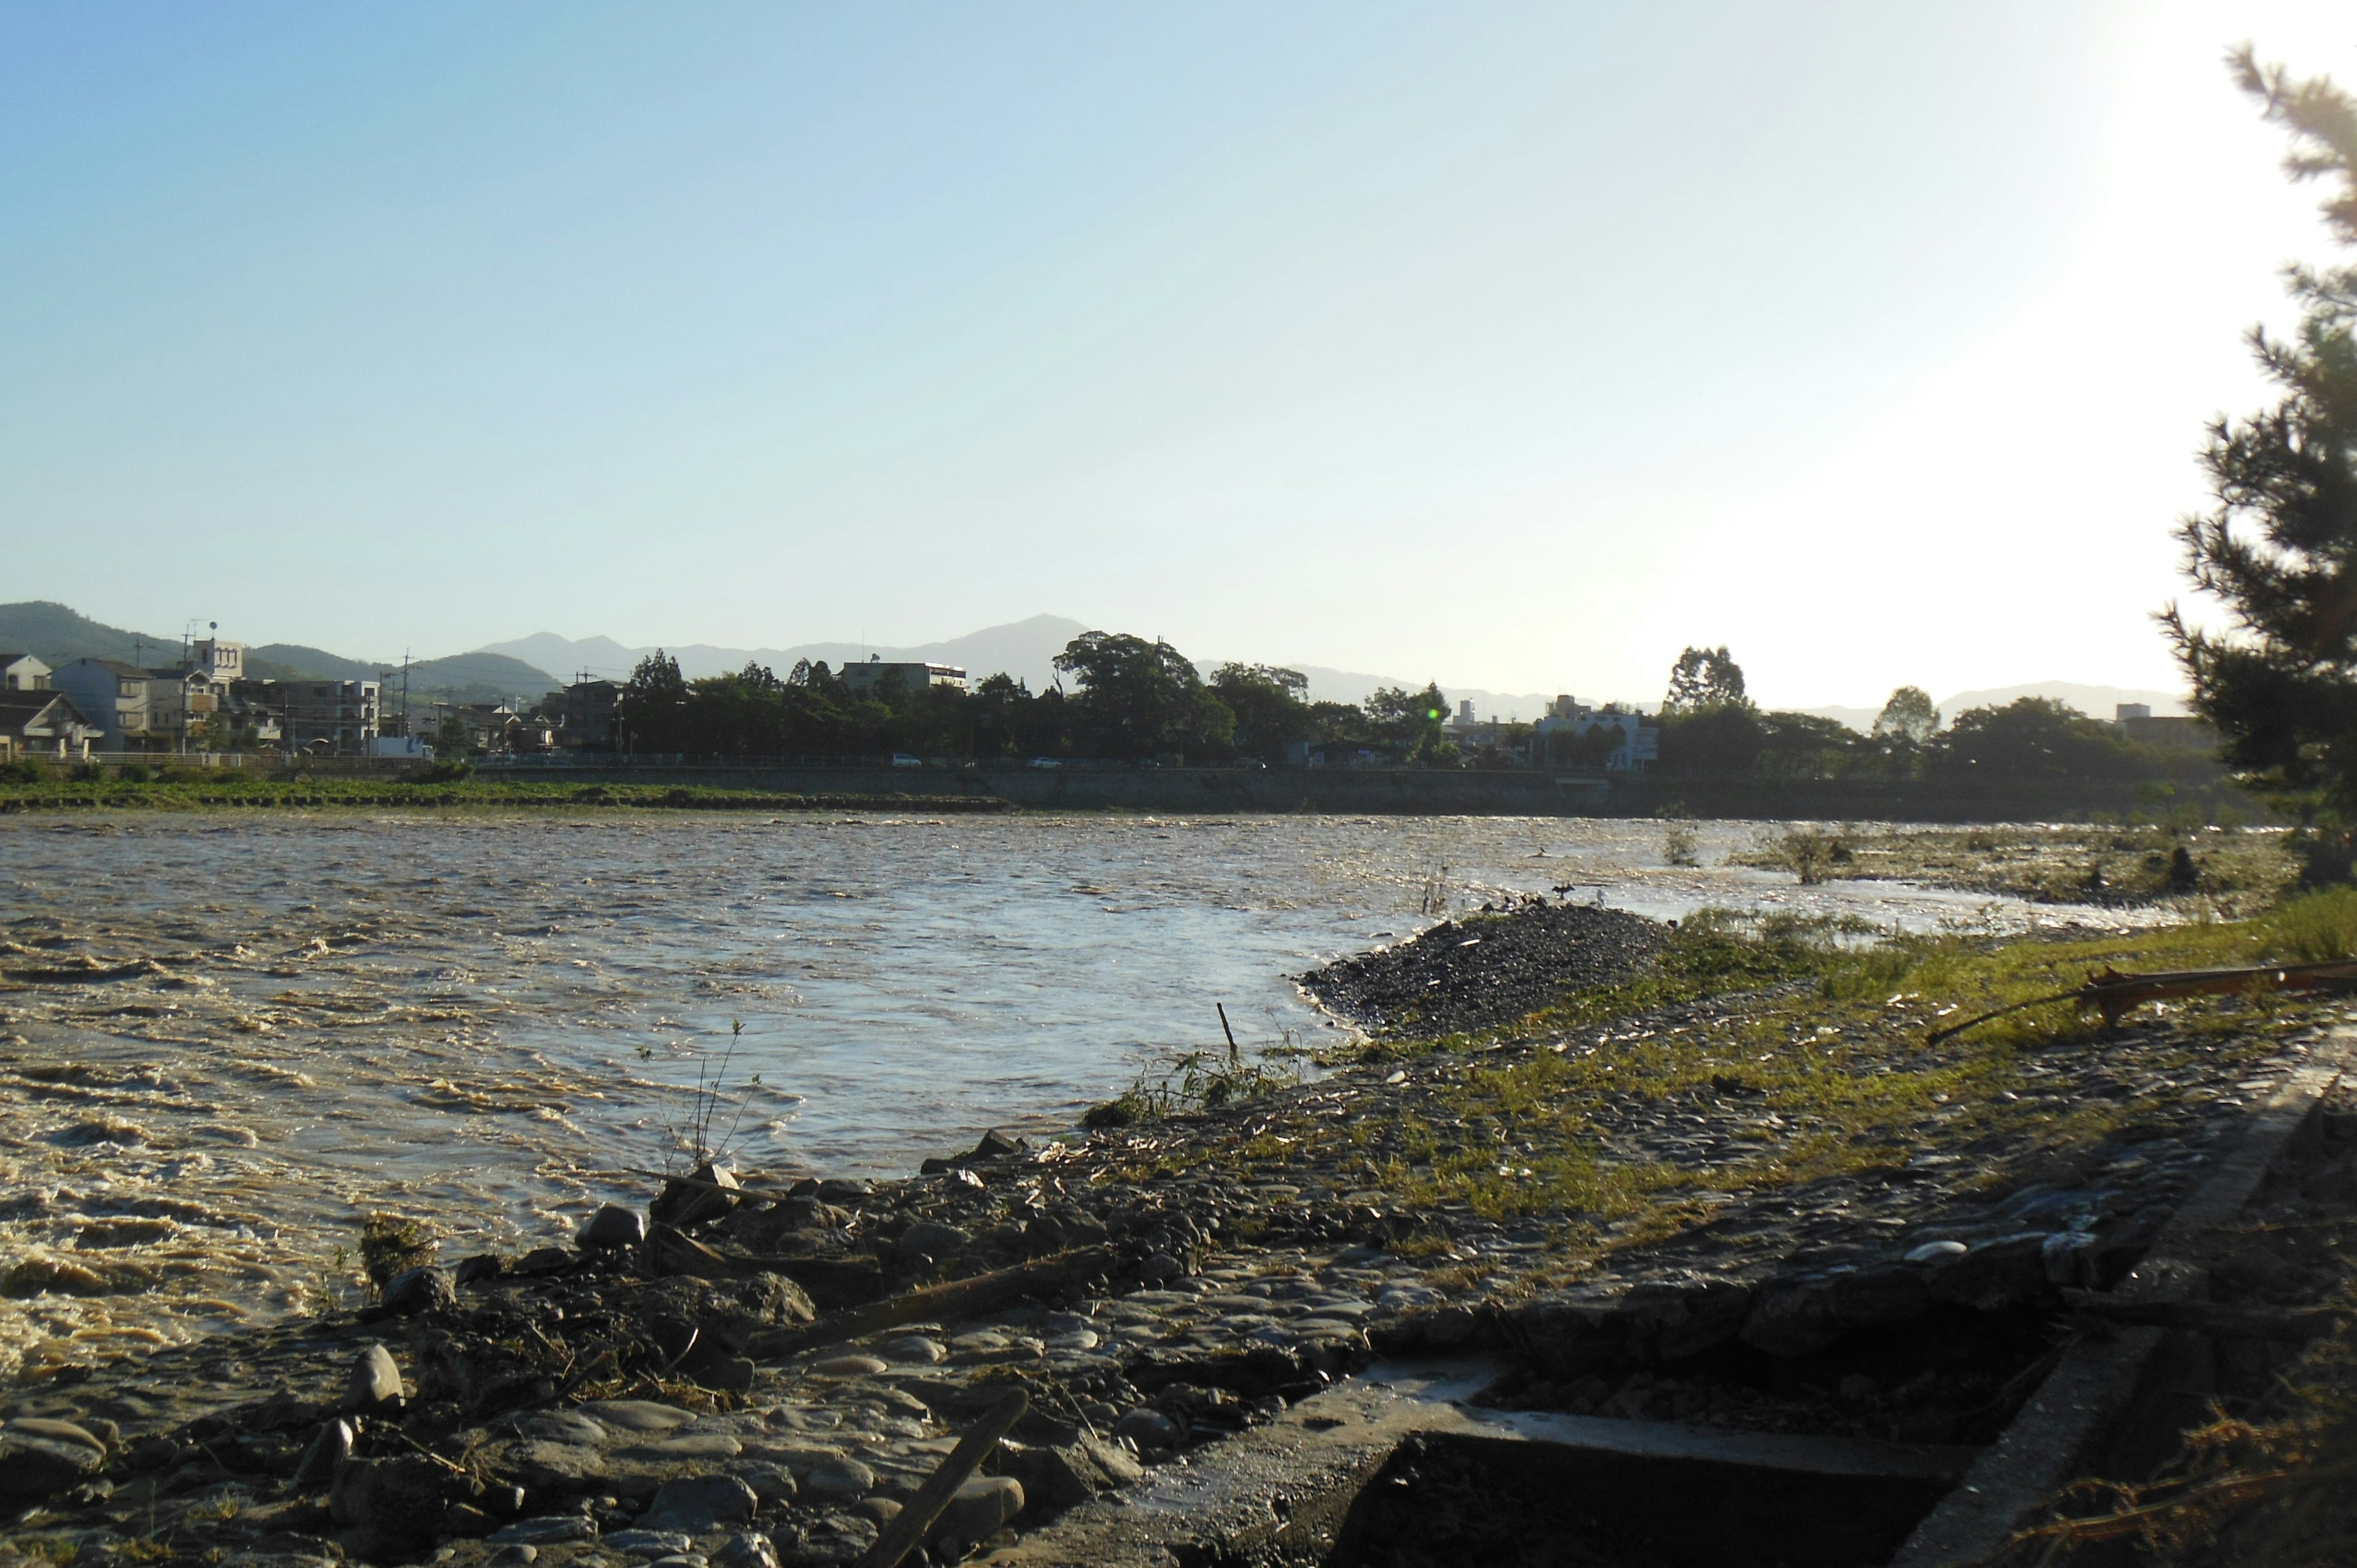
[1301,903,1669,1035]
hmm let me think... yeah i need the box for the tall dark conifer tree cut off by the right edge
[2161,47,2357,832]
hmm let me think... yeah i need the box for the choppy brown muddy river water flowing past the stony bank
[0,811,2140,1372]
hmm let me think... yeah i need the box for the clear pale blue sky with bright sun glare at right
[0,0,2357,703]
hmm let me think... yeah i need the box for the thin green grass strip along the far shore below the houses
[0,776,1009,811]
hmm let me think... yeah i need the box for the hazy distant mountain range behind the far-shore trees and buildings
[0,601,2185,731]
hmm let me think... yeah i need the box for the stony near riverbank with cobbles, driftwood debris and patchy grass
[0,898,2357,1568]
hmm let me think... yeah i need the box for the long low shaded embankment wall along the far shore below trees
[483,764,2187,823]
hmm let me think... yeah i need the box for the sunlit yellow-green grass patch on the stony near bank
[1117,889,2357,1266]
